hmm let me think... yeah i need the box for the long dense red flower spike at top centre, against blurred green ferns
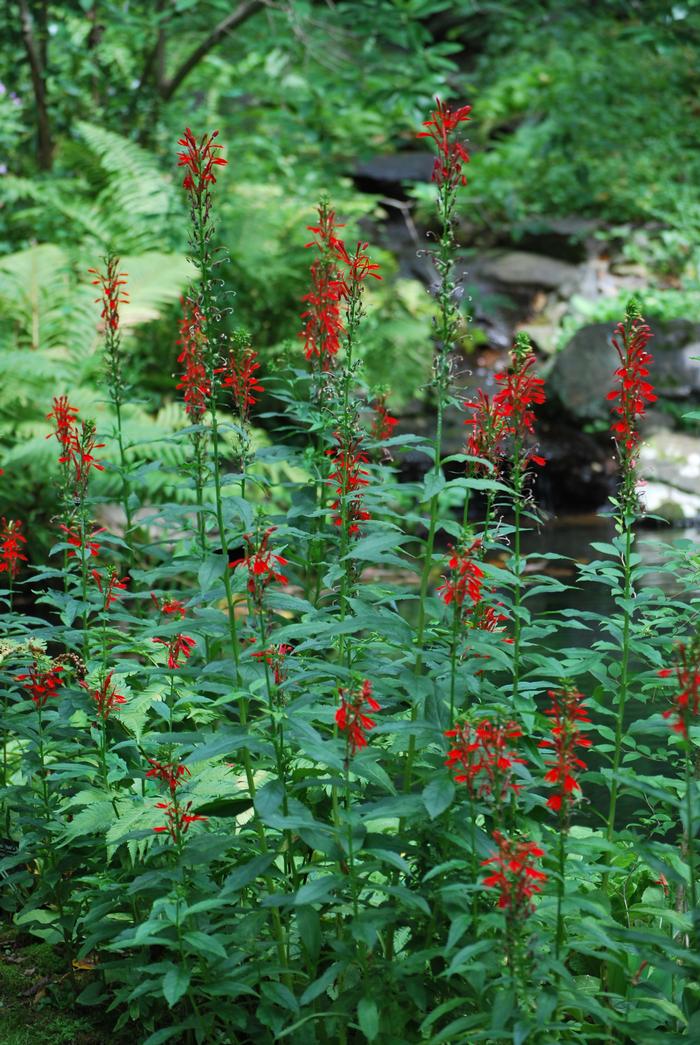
[300,203,344,370]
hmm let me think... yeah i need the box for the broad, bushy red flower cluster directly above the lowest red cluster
[445,719,524,803]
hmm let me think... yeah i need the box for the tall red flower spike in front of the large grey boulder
[607,314,656,457]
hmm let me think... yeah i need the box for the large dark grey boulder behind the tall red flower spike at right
[546,319,700,421]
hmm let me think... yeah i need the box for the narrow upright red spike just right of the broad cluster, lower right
[538,687,591,812]
